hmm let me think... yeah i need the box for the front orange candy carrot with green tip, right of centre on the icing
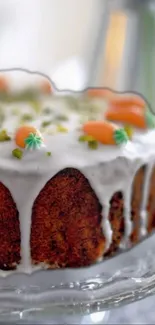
[83,121,128,145]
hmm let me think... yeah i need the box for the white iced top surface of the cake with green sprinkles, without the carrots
[0,73,155,173]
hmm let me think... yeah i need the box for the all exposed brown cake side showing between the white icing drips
[0,166,155,270]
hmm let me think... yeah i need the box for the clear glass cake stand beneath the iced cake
[0,235,155,324]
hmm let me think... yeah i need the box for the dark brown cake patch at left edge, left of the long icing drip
[0,182,20,270]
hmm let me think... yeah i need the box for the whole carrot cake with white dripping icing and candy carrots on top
[0,79,155,274]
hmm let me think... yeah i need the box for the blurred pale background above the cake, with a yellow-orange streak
[0,0,155,104]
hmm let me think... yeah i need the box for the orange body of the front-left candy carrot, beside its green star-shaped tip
[15,125,40,148]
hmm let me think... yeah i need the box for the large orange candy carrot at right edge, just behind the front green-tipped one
[105,106,155,129]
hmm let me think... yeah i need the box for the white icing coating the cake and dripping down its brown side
[0,90,155,274]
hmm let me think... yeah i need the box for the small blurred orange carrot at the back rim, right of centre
[86,88,114,99]
